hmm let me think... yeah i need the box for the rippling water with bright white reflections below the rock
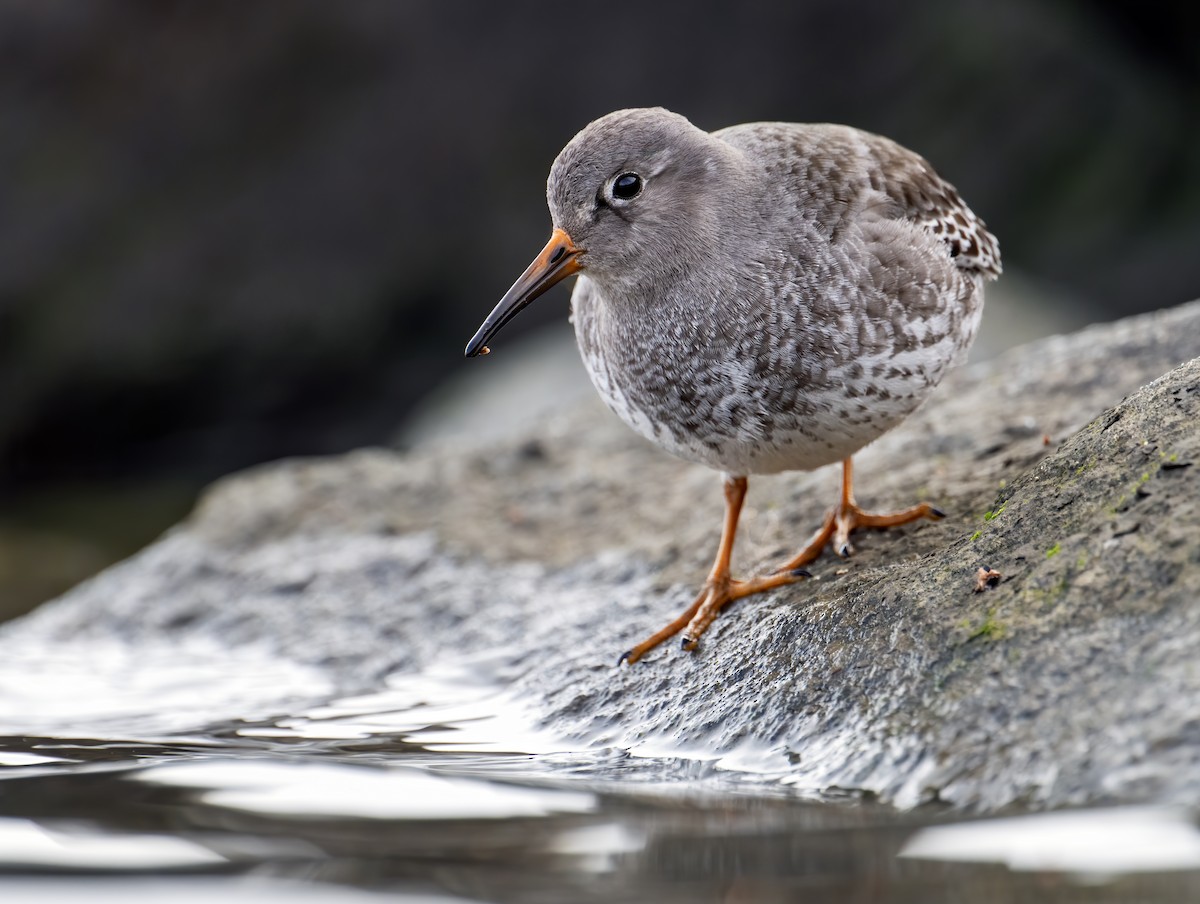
[0,642,1200,904]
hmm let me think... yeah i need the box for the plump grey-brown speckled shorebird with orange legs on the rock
[467,108,1000,661]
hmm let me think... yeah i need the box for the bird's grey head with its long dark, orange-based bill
[467,107,743,357]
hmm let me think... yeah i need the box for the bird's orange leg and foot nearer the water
[620,477,808,664]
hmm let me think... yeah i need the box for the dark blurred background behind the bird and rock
[0,0,1200,611]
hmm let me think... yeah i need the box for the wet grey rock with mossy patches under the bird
[0,303,1200,810]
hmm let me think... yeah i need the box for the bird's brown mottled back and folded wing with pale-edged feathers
[713,122,1001,279]
